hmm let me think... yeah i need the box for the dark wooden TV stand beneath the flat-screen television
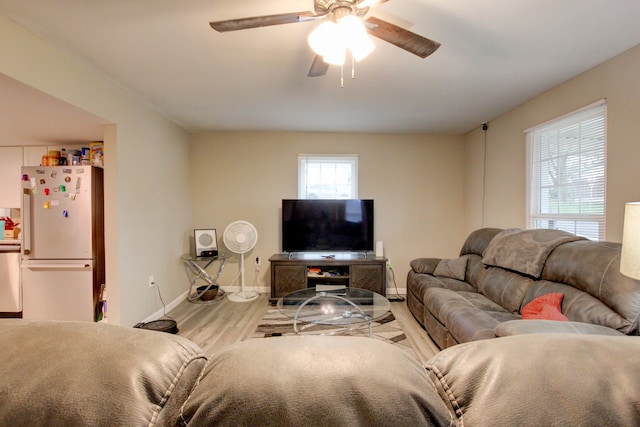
[269,253,387,304]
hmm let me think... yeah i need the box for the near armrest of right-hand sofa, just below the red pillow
[494,319,624,337]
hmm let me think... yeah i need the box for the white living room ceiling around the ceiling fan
[0,0,640,138]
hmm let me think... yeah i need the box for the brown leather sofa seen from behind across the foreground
[0,319,640,427]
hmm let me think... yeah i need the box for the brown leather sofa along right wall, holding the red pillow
[407,228,640,349]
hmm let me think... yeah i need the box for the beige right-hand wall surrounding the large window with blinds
[464,46,640,242]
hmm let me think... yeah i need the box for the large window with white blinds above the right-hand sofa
[526,101,607,240]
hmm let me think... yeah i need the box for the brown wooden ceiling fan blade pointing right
[365,16,440,58]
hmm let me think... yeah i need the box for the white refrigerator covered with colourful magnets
[21,165,105,321]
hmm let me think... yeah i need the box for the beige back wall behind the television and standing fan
[191,132,466,294]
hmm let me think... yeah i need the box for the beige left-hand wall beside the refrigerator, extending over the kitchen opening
[0,17,191,326]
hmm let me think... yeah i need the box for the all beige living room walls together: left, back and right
[10,10,640,325]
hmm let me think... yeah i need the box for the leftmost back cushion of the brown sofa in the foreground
[0,319,206,426]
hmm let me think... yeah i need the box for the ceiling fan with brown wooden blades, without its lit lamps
[210,0,440,77]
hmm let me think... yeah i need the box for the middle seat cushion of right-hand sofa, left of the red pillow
[423,288,520,342]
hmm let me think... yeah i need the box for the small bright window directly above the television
[298,154,358,199]
